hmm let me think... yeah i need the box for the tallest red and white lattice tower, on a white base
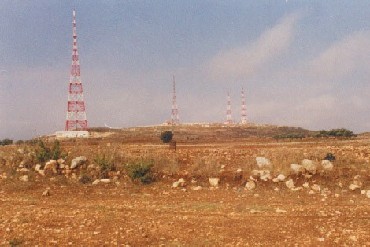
[65,10,87,131]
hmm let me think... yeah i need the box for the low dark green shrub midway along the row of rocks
[126,162,154,184]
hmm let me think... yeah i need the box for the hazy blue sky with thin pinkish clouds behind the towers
[0,0,370,139]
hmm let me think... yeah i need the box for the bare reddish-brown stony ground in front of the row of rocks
[0,178,370,246]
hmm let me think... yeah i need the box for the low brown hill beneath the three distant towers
[89,124,316,143]
